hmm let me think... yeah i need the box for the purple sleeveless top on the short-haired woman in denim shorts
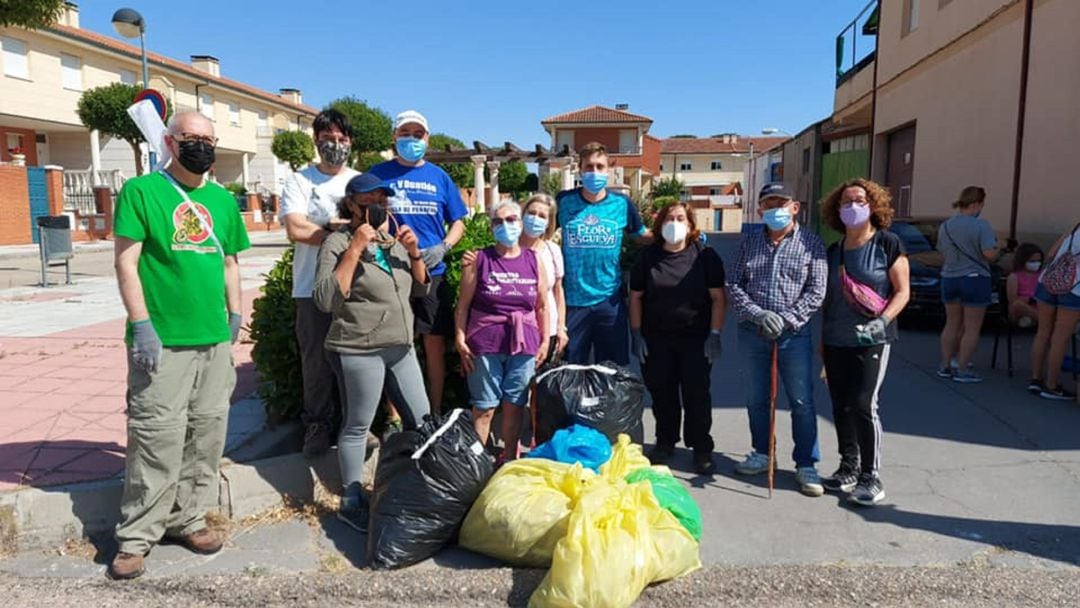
[467,247,540,355]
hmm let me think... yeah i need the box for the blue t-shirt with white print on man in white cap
[368,160,469,276]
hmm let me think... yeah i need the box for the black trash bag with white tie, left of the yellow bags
[367,409,495,570]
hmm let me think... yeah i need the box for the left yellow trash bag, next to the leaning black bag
[458,458,597,568]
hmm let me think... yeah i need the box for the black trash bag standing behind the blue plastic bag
[532,361,645,444]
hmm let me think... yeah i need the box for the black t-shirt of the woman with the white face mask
[630,243,724,338]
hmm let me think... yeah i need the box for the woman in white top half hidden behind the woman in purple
[521,192,570,361]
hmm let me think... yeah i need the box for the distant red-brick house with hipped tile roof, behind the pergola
[540,106,660,193]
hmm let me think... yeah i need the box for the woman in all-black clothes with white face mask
[630,203,725,475]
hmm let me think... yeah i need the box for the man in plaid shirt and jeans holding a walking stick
[728,184,828,496]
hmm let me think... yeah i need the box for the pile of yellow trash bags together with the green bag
[459,434,701,608]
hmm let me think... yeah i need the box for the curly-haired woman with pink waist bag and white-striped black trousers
[821,178,910,506]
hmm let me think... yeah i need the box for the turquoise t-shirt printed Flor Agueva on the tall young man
[556,190,645,307]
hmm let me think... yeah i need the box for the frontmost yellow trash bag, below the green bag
[529,477,701,608]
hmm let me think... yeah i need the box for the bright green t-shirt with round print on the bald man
[113,173,251,347]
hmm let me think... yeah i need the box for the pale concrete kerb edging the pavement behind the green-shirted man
[0,440,379,554]
